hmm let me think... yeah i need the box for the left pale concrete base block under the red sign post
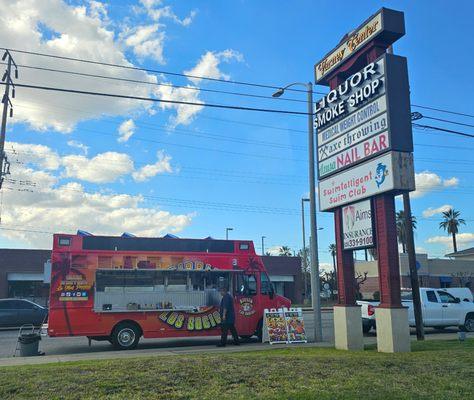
[334,305,364,350]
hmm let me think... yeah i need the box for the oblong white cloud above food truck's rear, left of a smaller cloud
[62,151,134,183]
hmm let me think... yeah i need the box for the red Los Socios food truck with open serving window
[48,234,290,349]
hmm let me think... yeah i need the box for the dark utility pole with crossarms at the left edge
[0,50,18,189]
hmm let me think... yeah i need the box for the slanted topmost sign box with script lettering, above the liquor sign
[314,8,405,85]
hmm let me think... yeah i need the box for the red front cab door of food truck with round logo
[234,273,261,336]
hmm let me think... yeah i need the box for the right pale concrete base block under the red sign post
[375,307,410,353]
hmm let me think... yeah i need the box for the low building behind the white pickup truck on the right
[355,253,474,298]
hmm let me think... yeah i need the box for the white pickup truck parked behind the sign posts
[357,288,474,333]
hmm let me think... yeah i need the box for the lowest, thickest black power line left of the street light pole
[0,82,308,115]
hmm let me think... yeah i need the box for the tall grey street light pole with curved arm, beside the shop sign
[273,82,323,342]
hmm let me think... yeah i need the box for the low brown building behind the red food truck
[0,249,303,305]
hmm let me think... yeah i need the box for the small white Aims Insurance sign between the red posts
[342,200,374,250]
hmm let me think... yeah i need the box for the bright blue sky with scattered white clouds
[0,0,474,263]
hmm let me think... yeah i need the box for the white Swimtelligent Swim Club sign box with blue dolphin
[318,151,415,211]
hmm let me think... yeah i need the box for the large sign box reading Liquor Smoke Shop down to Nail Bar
[315,54,413,179]
